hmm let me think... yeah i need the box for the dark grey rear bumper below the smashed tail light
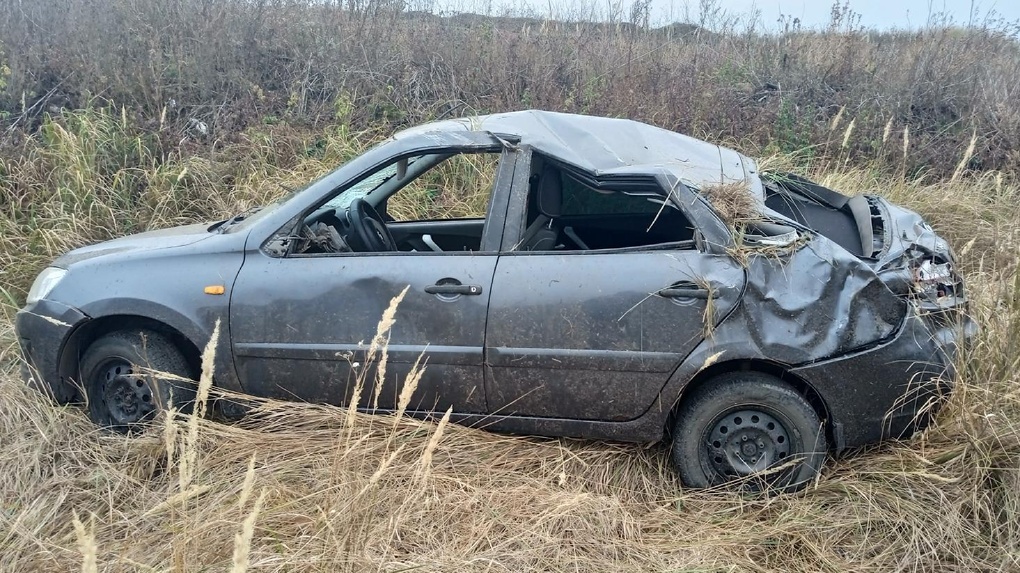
[792,305,977,451]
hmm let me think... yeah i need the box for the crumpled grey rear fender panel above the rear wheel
[650,235,926,447]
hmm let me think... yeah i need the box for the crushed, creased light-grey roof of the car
[394,110,760,193]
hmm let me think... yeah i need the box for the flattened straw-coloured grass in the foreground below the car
[0,283,1020,571]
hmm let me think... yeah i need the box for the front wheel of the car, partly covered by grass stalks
[79,330,195,432]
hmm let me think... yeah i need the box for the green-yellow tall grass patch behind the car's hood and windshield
[0,108,380,302]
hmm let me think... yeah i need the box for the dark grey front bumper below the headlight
[14,300,89,404]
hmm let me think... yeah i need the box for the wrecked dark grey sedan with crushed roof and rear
[16,111,975,490]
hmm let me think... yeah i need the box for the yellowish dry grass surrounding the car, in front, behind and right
[0,110,1020,572]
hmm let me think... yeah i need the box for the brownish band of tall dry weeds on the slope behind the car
[0,0,1020,175]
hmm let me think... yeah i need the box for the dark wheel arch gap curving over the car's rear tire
[663,358,844,451]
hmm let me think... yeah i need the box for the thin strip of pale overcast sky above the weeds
[436,0,1020,30]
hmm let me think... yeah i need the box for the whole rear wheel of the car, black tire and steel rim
[672,371,827,491]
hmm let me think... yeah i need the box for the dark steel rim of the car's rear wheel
[702,409,794,481]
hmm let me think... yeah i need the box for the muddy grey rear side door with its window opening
[486,158,744,421]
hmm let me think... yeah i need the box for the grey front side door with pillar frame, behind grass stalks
[231,144,514,413]
